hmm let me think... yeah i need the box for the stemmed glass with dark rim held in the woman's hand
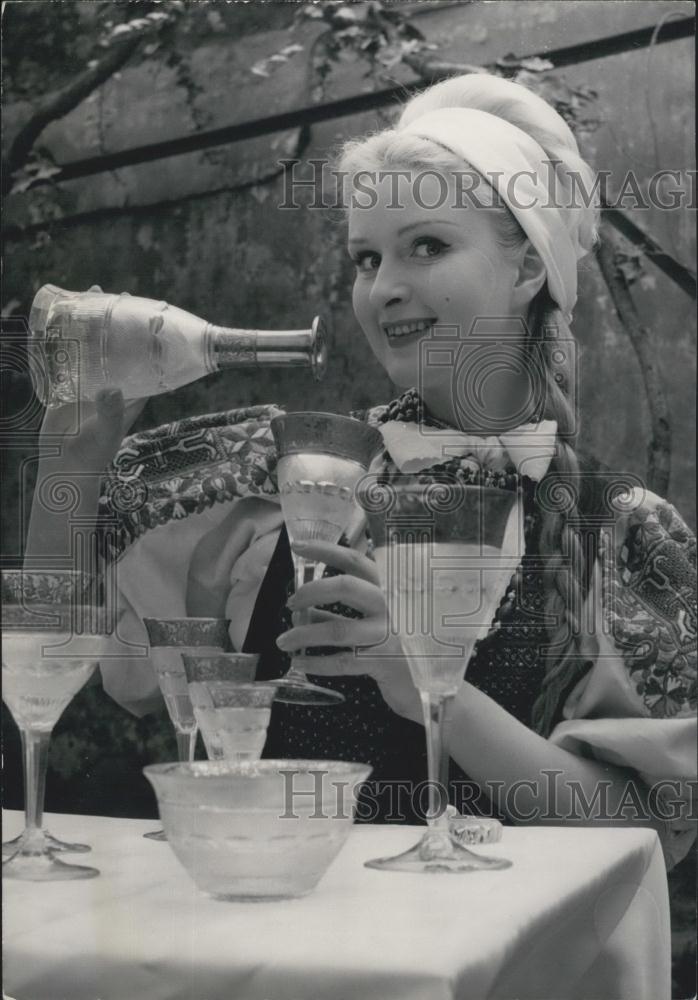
[270,412,383,705]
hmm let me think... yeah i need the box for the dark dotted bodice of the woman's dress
[245,394,592,822]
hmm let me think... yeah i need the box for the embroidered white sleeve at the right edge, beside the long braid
[551,492,697,867]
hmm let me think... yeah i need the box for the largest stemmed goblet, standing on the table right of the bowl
[358,475,522,872]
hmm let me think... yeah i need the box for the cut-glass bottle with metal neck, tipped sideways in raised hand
[29,285,327,407]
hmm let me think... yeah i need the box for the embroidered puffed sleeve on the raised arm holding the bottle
[99,406,282,715]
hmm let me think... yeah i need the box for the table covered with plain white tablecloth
[4,813,670,1000]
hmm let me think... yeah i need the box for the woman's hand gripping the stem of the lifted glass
[277,542,422,722]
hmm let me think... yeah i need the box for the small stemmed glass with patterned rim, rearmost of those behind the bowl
[143,617,230,840]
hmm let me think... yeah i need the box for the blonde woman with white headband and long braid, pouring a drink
[29,74,696,866]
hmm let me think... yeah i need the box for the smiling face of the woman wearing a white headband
[348,171,523,422]
